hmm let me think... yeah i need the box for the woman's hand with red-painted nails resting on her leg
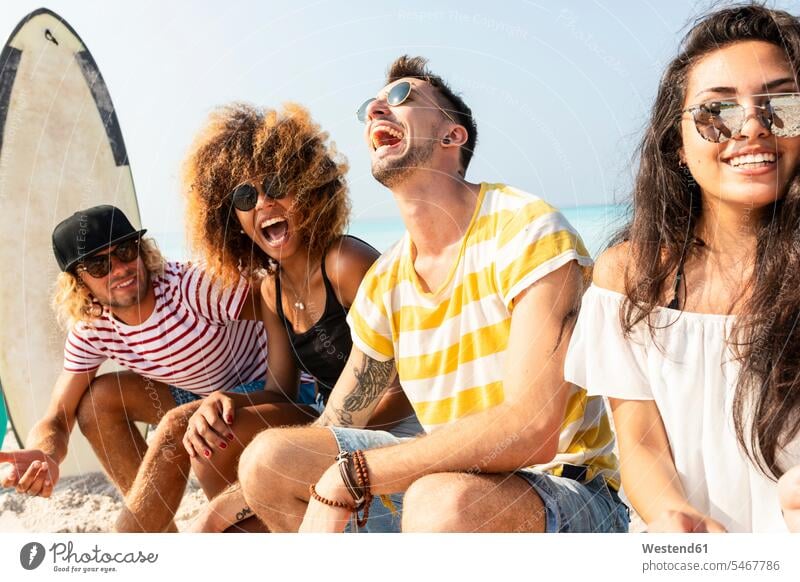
[183,392,235,458]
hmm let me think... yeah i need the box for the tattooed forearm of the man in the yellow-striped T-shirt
[314,346,397,428]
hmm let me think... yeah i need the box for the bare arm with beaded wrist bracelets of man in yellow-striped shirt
[317,261,583,501]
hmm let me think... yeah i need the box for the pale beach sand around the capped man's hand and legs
[0,424,205,533]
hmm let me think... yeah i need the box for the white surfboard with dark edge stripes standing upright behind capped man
[0,9,141,476]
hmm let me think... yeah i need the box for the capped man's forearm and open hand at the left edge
[0,370,97,497]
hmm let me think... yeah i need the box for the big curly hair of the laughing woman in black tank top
[183,103,350,284]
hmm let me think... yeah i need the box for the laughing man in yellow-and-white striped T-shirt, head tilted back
[239,56,628,532]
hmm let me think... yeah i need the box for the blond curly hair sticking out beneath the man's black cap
[52,238,166,331]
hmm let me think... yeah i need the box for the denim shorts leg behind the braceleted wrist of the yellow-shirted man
[330,416,422,533]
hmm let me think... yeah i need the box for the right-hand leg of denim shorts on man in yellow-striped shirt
[514,469,630,533]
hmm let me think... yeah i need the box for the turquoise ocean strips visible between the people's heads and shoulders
[158,204,626,260]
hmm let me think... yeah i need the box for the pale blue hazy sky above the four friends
[0,0,798,241]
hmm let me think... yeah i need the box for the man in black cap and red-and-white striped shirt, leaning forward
[0,206,279,532]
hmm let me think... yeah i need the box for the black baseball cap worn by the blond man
[53,204,147,271]
